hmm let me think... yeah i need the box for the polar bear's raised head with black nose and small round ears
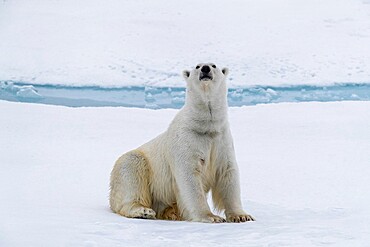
[182,63,229,97]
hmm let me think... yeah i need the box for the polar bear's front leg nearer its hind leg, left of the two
[172,152,226,223]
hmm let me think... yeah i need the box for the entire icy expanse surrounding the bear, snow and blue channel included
[0,0,370,244]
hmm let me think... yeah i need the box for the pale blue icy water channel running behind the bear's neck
[0,81,370,109]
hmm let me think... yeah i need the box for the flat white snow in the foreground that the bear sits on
[0,101,370,246]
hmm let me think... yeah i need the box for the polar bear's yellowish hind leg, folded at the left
[110,151,156,219]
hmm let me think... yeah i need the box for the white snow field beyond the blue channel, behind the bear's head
[0,0,370,87]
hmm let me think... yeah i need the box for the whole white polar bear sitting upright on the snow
[110,63,254,223]
